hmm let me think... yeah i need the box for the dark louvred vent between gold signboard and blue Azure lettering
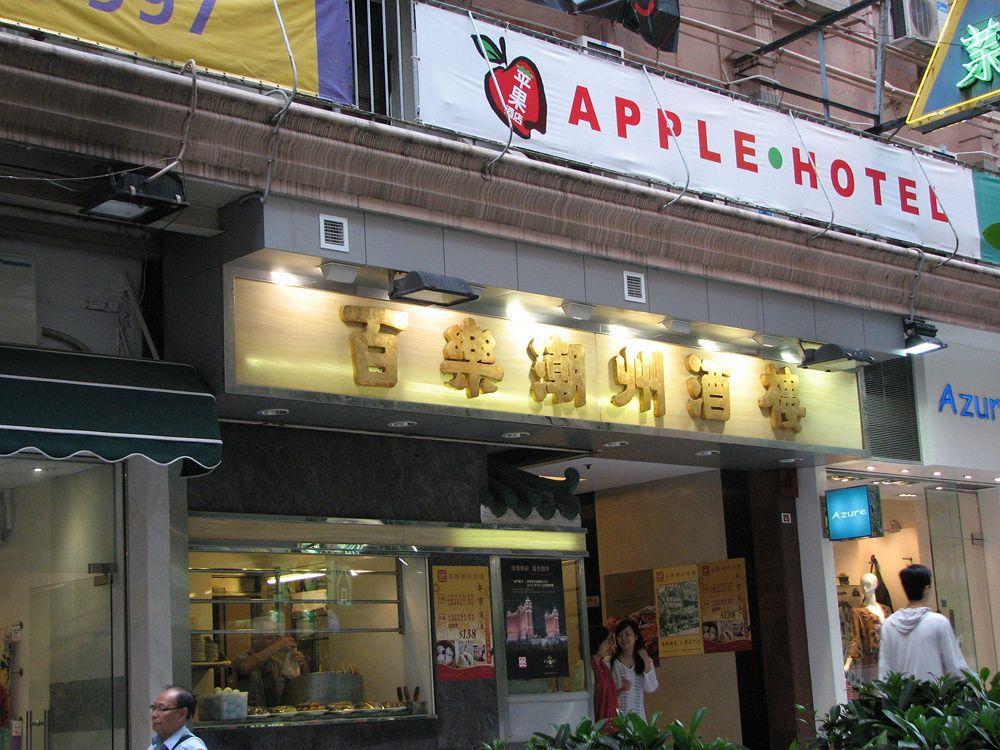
[862,357,920,462]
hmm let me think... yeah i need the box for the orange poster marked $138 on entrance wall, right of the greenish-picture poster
[698,557,753,654]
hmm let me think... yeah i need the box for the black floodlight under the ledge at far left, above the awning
[80,172,191,224]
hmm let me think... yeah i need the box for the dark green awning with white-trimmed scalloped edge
[0,347,222,475]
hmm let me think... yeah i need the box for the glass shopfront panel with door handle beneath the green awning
[0,459,125,750]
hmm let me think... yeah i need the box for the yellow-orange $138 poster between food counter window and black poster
[431,565,496,682]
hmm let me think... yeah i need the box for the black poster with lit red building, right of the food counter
[500,558,569,680]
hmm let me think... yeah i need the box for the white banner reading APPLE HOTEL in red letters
[416,5,980,258]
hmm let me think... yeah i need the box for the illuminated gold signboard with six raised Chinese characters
[227,277,862,449]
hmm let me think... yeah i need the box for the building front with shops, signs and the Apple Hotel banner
[0,0,1000,748]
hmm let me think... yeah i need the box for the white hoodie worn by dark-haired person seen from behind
[878,607,969,680]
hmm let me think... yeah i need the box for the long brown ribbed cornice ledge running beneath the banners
[0,35,1000,331]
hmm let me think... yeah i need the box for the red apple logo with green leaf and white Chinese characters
[472,35,547,138]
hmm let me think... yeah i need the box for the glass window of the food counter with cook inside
[189,551,433,720]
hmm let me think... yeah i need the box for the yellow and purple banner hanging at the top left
[0,0,354,104]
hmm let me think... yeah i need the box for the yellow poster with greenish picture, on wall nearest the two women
[653,565,704,657]
